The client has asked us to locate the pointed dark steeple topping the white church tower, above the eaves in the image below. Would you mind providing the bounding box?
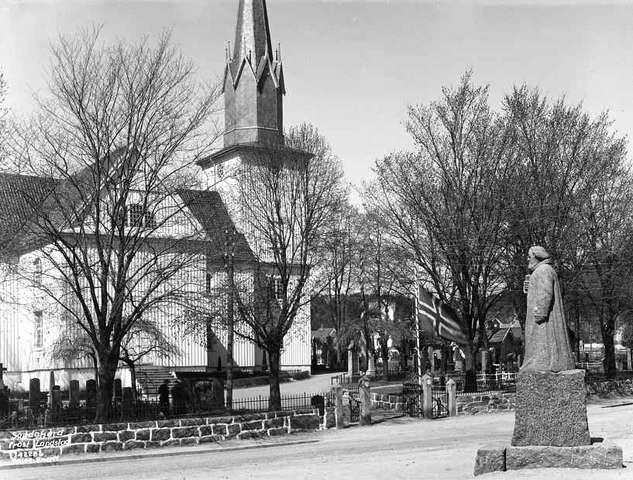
[224,0,285,147]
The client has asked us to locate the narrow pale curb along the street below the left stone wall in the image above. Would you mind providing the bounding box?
[0,439,319,471]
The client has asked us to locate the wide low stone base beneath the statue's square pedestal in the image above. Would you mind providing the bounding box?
[474,439,622,476]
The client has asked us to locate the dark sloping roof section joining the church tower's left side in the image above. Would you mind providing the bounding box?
[178,190,255,262]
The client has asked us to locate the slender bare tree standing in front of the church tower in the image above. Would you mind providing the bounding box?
[232,124,344,409]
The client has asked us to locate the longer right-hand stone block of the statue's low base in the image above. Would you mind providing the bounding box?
[506,440,622,470]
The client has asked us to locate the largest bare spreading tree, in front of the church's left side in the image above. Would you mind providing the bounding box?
[11,31,219,421]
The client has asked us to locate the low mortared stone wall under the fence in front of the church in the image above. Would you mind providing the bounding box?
[0,410,324,462]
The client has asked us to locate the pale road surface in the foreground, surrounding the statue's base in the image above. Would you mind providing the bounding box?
[0,402,633,480]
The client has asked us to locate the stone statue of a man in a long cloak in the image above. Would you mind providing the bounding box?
[521,246,575,372]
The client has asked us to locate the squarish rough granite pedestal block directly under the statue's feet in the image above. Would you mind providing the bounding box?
[512,370,591,447]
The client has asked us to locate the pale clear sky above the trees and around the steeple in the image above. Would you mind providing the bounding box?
[0,0,633,191]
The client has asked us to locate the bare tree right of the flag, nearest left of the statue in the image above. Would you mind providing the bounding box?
[370,74,514,389]
